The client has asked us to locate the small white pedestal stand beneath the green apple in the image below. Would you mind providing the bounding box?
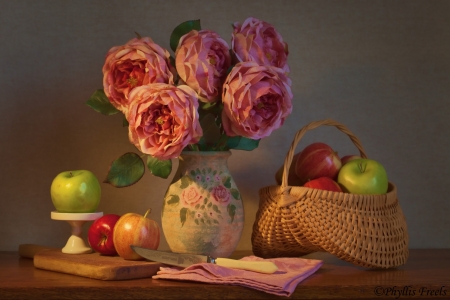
[51,211,103,254]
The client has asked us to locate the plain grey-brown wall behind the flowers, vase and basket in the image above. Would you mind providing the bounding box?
[0,0,450,251]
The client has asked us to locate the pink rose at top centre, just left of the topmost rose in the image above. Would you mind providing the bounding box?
[175,30,231,102]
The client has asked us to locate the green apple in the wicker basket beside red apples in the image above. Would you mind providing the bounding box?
[337,158,388,194]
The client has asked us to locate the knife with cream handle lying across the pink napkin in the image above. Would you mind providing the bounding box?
[130,245,278,274]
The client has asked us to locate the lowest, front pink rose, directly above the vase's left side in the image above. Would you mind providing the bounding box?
[126,83,203,160]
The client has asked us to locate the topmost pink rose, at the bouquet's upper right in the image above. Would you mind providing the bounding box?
[231,18,289,73]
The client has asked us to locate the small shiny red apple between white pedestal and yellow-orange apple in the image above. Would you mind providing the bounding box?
[88,214,120,255]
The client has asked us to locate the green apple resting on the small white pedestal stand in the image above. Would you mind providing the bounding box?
[50,170,101,213]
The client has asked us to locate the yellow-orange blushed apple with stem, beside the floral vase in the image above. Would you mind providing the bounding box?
[113,209,160,260]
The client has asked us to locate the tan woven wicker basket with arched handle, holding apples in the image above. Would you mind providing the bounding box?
[252,120,409,268]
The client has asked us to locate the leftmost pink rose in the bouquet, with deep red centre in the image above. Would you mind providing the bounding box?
[103,37,174,112]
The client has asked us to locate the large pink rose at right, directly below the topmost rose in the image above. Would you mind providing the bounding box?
[222,62,293,139]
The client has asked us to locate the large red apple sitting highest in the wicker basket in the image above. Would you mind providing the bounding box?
[295,143,342,184]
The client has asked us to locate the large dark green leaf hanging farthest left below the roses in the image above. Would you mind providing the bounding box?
[104,152,145,187]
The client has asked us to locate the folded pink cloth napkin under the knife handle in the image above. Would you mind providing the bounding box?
[152,256,323,297]
